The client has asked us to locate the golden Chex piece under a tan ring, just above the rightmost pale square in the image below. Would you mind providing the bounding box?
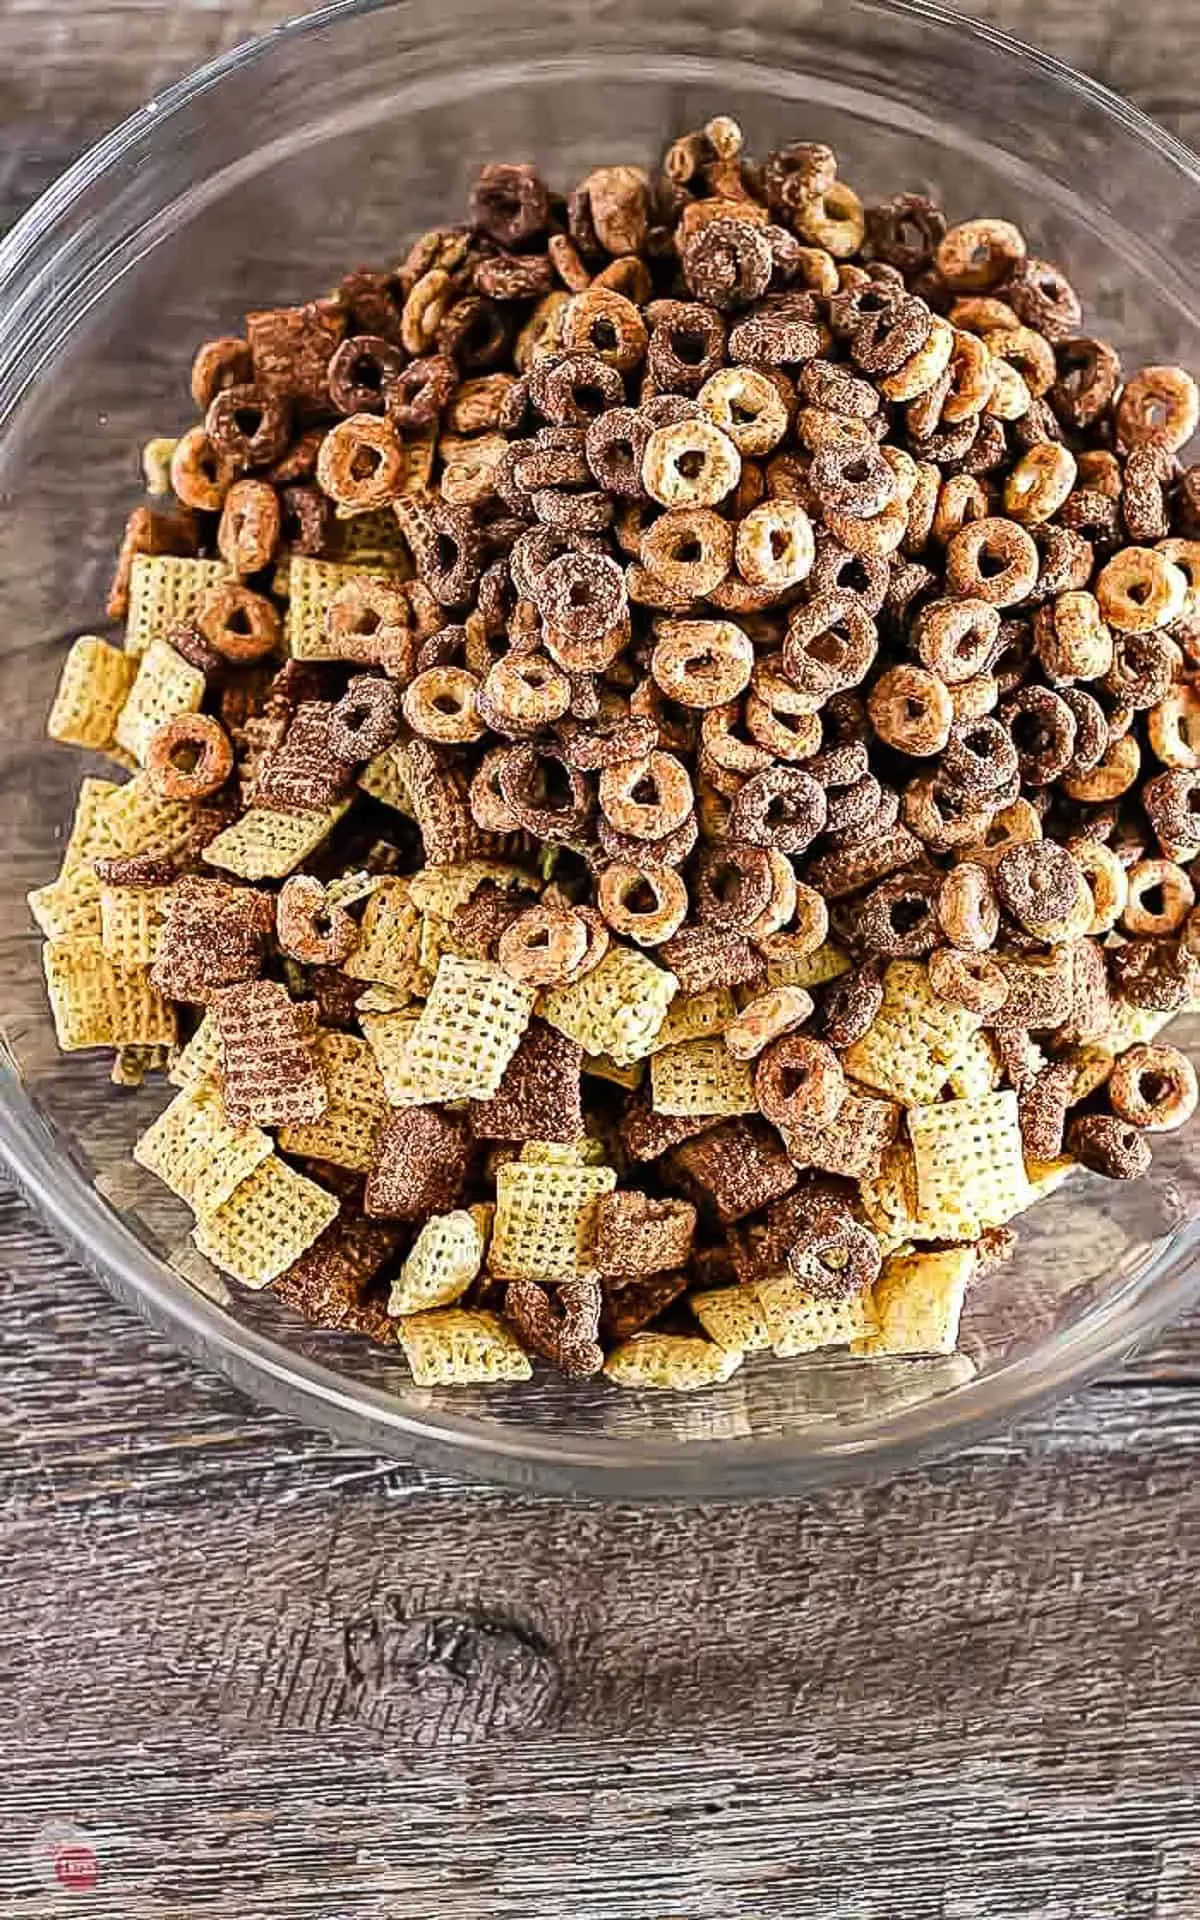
[843,960,979,1106]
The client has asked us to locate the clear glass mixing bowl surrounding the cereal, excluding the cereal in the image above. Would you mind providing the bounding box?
[0,0,1200,1498]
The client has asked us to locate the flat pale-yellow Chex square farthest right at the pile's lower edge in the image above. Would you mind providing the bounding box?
[908,1089,1031,1227]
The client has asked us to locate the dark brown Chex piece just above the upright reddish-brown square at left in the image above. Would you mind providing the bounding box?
[152,874,273,1006]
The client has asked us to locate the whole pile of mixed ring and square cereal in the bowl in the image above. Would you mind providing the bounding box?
[31,119,1200,1388]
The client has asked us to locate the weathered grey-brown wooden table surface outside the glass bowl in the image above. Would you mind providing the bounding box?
[0,0,1200,1920]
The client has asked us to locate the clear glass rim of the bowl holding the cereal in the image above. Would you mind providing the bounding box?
[0,0,1200,1500]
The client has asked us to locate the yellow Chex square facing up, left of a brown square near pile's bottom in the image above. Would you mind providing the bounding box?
[488,1160,616,1281]
